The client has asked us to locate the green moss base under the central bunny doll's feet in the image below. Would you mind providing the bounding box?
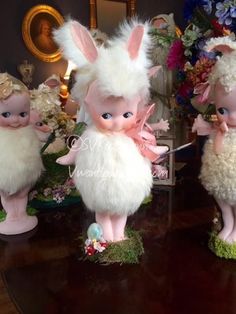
[86,229,144,265]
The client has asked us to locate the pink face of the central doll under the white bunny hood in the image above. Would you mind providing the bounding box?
[85,84,140,132]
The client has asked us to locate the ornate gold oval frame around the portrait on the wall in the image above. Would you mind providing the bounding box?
[22,5,64,62]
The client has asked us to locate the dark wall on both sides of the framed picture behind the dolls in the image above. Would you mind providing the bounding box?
[0,0,184,87]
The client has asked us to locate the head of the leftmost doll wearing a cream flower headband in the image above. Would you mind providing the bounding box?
[0,73,30,129]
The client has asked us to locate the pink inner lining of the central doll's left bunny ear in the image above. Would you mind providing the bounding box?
[71,21,98,63]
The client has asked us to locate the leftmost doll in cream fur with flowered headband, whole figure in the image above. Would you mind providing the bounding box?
[0,73,43,235]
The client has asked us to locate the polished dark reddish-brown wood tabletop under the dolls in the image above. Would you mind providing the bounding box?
[0,164,236,314]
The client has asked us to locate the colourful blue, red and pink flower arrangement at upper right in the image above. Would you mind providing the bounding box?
[166,0,236,116]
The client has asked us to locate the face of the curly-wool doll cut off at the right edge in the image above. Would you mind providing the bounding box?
[214,83,236,127]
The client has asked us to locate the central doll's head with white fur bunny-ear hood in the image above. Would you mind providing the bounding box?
[54,20,151,115]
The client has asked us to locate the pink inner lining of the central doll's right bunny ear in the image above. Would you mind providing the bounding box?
[127,25,144,60]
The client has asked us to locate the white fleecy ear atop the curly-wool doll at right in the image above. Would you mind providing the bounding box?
[205,37,236,54]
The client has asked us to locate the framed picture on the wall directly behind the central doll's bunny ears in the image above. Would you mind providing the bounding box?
[90,0,136,34]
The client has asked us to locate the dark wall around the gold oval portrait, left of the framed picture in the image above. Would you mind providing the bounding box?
[0,0,89,87]
